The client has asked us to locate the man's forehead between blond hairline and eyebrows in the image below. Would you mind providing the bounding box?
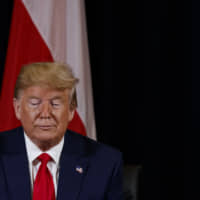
[20,86,70,99]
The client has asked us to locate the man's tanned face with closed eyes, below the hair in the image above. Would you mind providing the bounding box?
[14,86,74,150]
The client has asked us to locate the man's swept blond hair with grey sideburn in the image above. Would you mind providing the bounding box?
[14,62,78,108]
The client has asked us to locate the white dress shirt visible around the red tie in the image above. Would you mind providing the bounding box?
[24,133,64,195]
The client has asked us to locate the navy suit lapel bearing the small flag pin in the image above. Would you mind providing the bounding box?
[57,133,88,200]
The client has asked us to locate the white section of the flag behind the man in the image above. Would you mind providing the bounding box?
[22,0,96,139]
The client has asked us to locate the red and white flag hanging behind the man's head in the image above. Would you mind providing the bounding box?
[0,0,96,139]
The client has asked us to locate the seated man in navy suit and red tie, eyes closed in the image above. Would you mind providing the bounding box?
[0,63,122,200]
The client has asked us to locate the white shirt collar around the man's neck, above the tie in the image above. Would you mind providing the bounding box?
[24,132,64,166]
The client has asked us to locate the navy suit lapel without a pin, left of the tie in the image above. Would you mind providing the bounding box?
[1,127,31,200]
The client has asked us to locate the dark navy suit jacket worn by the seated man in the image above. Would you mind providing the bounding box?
[0,127,122,200]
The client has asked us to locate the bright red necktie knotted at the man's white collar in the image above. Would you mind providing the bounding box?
[33,153,56,200]
